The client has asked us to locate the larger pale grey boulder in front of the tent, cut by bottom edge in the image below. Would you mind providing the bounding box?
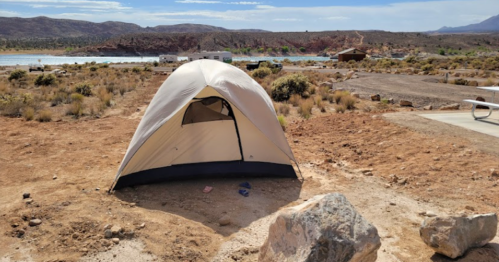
[259,193,381,262]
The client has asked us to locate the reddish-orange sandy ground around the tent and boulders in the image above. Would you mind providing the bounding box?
[0,70,499,262]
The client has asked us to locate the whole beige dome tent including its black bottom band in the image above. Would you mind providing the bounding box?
[111,60,296,190]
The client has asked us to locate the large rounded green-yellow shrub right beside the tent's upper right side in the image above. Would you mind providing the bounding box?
[271,74,310,101]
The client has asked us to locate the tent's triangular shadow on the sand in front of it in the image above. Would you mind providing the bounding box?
[115,178,302,236]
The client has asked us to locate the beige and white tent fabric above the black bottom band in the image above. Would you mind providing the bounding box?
[115,60,296,189]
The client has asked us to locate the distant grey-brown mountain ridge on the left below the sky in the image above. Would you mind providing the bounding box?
[0,16,266,39]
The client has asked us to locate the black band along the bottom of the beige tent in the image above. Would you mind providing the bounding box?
[114,161,297,189]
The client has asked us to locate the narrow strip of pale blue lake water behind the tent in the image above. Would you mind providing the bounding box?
[0,55,329,66]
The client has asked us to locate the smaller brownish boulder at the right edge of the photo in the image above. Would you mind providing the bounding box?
[419,213,497,258]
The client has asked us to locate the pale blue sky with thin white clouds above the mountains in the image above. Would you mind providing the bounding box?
[0,0,499,32]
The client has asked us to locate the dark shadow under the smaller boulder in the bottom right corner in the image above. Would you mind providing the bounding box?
[431,243,499,262]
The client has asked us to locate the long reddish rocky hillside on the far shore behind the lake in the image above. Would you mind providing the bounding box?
[72,31,499,56]
